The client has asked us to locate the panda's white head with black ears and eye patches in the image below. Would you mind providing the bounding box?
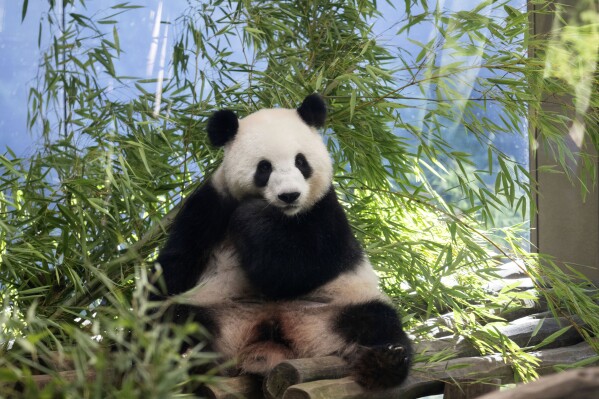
[207,94,333,216]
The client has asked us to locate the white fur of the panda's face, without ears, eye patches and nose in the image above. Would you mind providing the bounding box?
[217,109,333,215]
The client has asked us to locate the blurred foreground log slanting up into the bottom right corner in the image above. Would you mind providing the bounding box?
[479,367,599,399]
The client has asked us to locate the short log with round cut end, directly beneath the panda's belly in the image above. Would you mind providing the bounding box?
[263,356,349,399]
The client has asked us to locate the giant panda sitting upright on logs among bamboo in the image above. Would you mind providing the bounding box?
[157,94,412,389]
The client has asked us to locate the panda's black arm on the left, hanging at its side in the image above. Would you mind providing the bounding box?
[157,181,236,295]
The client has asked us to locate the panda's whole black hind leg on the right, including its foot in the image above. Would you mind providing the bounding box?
[334,300,412,390]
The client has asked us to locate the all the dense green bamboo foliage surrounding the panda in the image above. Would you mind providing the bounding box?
[0,0,599,397]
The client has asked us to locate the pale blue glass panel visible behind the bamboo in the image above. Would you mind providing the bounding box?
[0,0,528,239]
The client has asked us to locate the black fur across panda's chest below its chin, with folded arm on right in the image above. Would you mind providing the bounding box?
[230,187,363,299]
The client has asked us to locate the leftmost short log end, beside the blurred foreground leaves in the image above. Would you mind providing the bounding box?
[200,375,263,399]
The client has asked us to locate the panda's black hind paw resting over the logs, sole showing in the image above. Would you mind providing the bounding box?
[351,345,410,390]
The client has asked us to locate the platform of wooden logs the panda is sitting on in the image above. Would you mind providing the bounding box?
[206,343,599,399]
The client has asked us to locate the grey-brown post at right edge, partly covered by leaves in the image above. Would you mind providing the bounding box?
[528,0,599,283]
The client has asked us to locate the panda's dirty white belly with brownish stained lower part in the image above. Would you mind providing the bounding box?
[190,256,383,374]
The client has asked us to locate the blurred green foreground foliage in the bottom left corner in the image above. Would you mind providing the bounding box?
[0,269,217,398]
